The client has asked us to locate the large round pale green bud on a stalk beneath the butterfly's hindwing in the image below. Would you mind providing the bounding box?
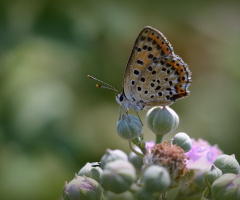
[146,106,179,136]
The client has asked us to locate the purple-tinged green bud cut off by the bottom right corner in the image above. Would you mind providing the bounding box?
[211,174,240,200]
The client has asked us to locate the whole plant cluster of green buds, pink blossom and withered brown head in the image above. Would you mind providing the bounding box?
[63,106,240,200]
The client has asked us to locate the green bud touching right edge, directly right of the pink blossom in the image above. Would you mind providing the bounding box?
[213,154,239,174]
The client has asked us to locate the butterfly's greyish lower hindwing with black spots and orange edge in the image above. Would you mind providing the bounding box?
[132,55,191,106]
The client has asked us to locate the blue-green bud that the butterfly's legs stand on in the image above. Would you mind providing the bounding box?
[117,115,143,140]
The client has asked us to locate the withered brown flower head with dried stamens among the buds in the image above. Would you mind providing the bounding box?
[144,142,189,185]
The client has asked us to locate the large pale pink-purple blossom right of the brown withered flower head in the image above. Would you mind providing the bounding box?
[186,138,223,170]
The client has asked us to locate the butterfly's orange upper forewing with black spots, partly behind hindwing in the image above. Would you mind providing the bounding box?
[123,26,174,99]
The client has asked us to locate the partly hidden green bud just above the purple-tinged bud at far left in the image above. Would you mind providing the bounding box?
[78,163,103,183]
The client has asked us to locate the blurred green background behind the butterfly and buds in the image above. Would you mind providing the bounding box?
[0,0,240,200]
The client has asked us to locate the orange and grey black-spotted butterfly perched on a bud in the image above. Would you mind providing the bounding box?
[88,26,191,119]
